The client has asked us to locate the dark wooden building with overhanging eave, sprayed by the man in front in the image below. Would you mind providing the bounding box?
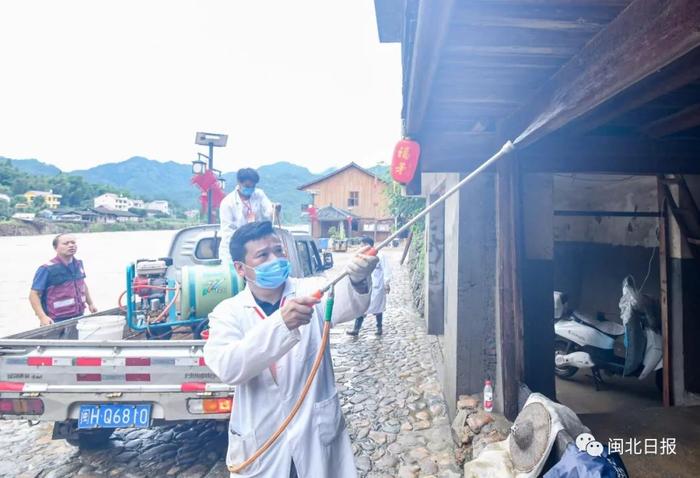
[375,0,700,476]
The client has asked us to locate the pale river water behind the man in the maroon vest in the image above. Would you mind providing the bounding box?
[0,231,176,337]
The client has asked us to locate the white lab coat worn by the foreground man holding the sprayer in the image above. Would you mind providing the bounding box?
[204,278,370,478]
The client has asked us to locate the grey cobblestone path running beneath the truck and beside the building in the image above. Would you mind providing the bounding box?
[0,254,461,478]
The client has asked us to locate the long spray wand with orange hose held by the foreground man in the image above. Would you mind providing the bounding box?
[228,141,515,473]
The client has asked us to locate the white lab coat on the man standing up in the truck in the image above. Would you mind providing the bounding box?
[219,188,273,264]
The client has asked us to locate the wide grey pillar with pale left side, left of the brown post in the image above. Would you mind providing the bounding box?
[443,173,499,416]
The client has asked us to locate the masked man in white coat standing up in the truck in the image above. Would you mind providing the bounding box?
[219,168,275,264]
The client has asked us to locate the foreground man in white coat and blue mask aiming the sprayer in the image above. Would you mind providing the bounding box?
[204,221,377,478]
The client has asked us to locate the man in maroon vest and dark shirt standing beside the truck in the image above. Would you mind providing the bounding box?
[29,234,97,326]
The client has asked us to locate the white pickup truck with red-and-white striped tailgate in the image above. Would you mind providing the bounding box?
[0,225,333,447]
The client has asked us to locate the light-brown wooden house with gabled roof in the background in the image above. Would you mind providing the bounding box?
[298,163,394,241]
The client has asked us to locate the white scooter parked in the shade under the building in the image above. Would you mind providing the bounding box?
[554,276,663,390]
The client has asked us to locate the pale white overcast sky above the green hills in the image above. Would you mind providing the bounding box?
[0,0,401,172]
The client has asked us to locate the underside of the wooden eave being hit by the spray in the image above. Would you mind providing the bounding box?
[403,0,700,175]
